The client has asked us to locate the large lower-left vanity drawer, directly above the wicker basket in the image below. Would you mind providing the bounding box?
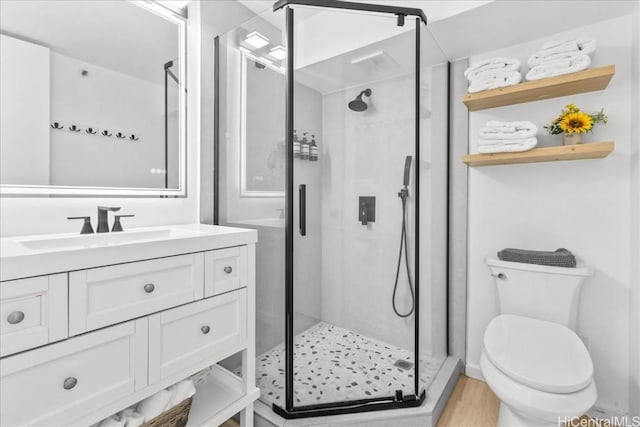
[0,319,148,427]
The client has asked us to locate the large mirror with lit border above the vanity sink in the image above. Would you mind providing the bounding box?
[0,0,186,196]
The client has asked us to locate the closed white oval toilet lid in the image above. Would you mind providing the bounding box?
[484,314,593,393]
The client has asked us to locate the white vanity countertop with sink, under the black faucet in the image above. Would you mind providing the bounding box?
[0,224,258,281]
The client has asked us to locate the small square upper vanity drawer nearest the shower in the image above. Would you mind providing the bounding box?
[204,246,247,297]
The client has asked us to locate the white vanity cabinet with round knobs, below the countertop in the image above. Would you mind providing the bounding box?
[0,226,259,427]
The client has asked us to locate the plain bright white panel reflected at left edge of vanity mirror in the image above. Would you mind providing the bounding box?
[0,34,50,185]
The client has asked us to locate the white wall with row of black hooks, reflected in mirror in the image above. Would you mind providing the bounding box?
[51,52,170,188]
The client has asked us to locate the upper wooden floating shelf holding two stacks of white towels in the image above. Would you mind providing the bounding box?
[462,65,616,111]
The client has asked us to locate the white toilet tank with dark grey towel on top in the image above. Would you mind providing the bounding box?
[485,258,593,330]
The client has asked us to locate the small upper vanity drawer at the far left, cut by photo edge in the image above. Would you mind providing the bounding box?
[0,273,68,357]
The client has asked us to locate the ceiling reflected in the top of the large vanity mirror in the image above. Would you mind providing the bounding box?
[0,0,179,83]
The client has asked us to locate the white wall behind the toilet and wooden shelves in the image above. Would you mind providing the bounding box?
[464,16,637,411]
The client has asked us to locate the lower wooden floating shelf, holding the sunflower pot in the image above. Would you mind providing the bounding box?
[462,141,614,166]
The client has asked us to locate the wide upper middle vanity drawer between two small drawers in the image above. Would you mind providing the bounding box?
[69,253,204,335]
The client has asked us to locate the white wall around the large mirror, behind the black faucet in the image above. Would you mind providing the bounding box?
[0,2,200,236]
